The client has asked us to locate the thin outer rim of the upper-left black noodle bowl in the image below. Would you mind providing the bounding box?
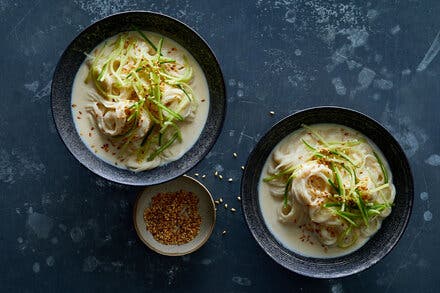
[49,10,227,186]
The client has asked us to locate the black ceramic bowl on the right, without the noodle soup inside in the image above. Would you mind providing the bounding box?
[241,107,414,278]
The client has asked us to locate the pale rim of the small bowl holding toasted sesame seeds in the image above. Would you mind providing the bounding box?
[133,175,217,256]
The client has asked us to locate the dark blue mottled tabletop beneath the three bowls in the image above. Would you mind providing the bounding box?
[0,0,440,292]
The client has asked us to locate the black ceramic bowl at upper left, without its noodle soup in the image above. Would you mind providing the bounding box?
[51,11,226,185]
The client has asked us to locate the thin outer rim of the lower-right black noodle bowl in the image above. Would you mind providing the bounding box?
[240,105,414,279]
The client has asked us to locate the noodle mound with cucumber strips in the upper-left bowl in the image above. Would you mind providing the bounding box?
[85,31,198,162]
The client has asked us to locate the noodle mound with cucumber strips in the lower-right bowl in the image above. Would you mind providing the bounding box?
[262,124,395,254]
